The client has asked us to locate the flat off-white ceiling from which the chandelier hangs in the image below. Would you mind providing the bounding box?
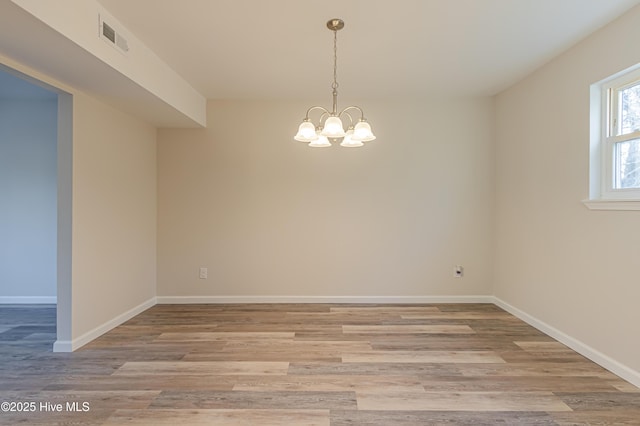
[99,0,640,99]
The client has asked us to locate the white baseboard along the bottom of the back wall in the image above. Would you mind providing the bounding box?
[157,296,493,305]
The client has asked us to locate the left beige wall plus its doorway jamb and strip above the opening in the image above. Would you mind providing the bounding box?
[0,54,157,350]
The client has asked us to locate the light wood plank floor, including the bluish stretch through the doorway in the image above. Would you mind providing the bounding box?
[0,304,640,426]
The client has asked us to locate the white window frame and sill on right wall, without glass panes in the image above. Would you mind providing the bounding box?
[583,64,640,210]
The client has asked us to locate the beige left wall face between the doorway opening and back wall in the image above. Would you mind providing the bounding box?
[72,93,156,339]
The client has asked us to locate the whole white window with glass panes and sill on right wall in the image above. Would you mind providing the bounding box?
[585,67,640,210]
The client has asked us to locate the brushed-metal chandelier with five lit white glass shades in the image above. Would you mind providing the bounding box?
[294,18,376,148]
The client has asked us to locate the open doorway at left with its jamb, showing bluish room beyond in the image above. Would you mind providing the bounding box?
[0,64,72,351]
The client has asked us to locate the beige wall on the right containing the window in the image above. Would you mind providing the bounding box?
[494,8,640,372]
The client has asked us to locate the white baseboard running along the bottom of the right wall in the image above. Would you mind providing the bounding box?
[493,297,640,388]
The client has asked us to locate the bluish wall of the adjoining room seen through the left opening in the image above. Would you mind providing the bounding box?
[0,98,57,303]
